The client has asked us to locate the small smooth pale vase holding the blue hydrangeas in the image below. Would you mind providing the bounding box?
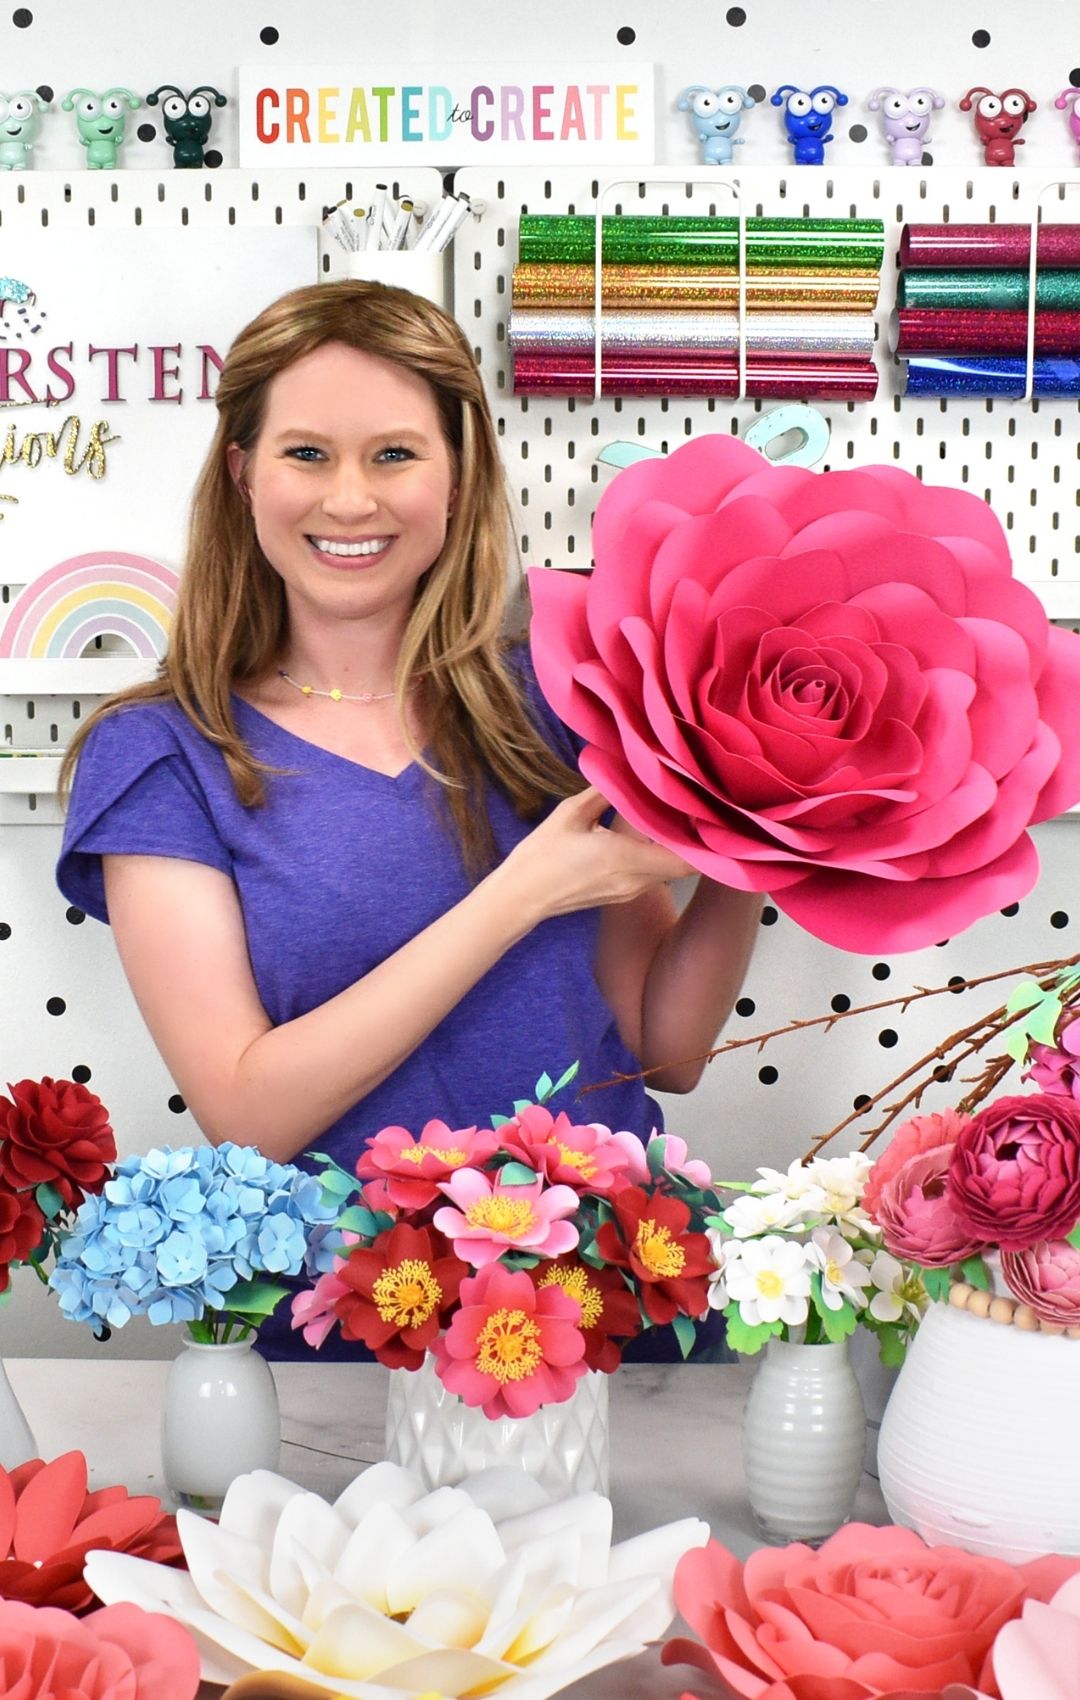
[162,1340,281,1515]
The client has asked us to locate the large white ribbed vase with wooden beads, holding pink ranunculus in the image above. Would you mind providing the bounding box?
[878,1304,1080,1561]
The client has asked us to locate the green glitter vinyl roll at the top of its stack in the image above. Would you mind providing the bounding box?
[517,213,884,270]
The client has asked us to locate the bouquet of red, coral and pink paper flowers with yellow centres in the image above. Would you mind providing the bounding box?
[293,1066,719,1418]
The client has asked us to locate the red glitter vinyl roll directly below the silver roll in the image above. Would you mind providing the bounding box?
[514,352,878,401]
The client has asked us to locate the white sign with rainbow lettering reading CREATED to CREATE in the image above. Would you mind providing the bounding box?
[240,61,657,168]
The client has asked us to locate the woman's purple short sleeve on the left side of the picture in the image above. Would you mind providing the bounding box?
[56,706,231,921]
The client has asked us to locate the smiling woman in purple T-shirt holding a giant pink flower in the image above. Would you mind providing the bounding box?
[58,282,759,1350]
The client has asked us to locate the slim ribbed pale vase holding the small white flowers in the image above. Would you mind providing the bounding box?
[743,1340,866,1544]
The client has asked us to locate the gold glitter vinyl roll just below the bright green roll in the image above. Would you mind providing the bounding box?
[510,265,879,313]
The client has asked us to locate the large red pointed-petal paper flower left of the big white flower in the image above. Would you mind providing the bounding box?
[0,1452,184,1611]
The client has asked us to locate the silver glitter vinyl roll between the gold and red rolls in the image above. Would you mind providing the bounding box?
[507,308,874,360]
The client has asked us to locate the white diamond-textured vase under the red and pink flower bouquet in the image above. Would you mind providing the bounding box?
[386,1357,609,1499]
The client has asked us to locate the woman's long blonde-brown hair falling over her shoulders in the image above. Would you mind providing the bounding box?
[60,282,583,876]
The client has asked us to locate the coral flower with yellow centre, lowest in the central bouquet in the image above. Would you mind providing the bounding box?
[432,1263,585,1418]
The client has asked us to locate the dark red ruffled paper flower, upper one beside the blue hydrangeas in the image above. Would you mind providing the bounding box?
[0,1074,116,1210]
